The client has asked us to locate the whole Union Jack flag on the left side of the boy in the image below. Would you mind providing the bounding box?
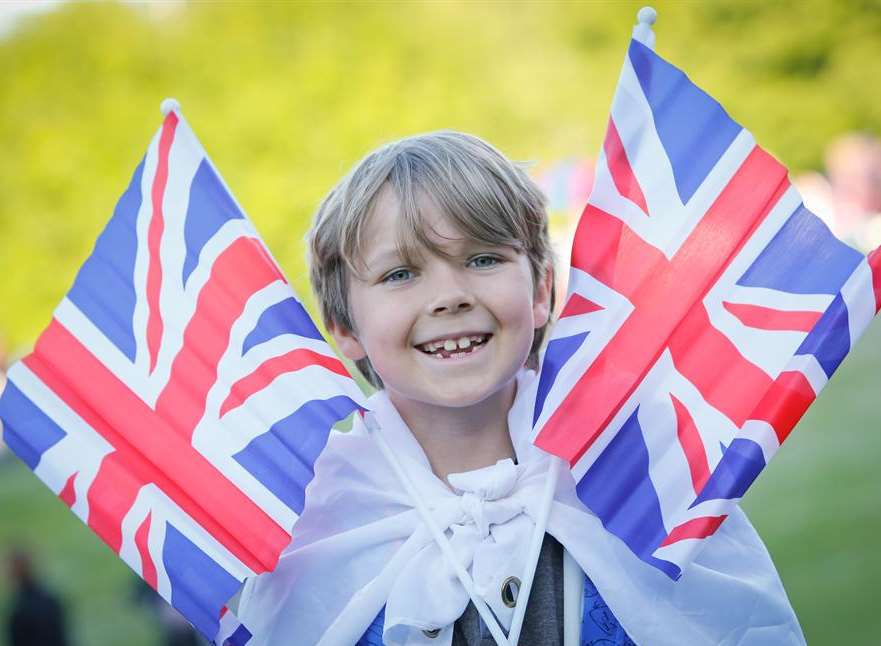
[0,107,363,644]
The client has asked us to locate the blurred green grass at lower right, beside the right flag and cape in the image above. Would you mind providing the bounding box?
[743,320,881,644]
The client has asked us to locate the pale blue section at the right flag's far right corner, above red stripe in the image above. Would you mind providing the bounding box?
[737,204,863,295]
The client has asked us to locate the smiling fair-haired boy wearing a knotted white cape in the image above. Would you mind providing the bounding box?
[239,132,804,646]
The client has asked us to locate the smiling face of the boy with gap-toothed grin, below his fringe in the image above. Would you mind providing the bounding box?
[331,188,550,408]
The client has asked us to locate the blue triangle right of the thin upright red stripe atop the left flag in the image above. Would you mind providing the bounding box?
[181,159,245,285]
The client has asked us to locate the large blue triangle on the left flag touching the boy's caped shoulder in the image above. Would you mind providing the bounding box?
[234,395,359,514]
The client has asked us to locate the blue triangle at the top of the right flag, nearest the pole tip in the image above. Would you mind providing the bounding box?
[629,40,743,204]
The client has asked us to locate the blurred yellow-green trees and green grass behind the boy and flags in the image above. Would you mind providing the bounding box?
[0,0,881,646]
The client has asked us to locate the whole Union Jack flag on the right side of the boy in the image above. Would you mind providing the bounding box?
[533,39,881,579]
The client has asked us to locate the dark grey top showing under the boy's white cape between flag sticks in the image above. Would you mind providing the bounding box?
[453,534,563,646]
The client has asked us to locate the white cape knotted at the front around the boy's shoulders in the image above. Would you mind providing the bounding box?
[239,372,804,646]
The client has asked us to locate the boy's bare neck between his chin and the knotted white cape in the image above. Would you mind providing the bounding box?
[388,381,517,484]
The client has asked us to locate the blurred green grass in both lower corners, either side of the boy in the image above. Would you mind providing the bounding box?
[0,321,881,646]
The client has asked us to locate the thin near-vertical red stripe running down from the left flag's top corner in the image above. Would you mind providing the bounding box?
[147,112,178,373]
